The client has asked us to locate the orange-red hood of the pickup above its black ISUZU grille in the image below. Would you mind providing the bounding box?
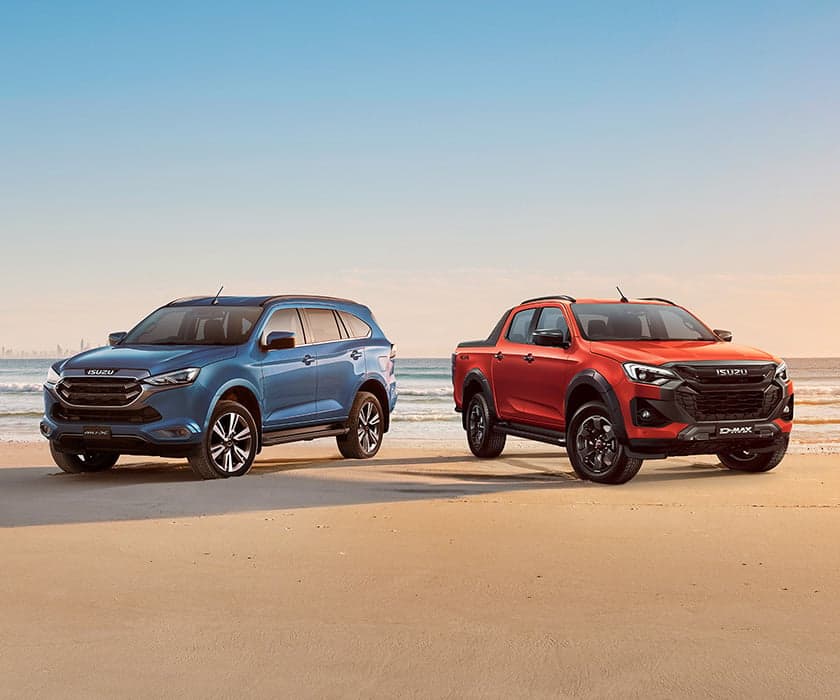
[590,340,781,365]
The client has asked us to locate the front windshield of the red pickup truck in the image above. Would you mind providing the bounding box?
[572,303,717,341]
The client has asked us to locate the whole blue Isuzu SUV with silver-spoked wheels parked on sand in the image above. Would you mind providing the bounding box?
[41,296,397,479]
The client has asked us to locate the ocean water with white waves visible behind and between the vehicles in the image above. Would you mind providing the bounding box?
[0,358,840,453]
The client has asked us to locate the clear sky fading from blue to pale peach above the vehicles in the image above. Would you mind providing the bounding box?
[0,0,840,357]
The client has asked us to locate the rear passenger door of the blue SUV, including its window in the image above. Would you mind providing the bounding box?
[303,308,366,421]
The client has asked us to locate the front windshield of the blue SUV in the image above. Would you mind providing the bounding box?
[120,306,262,345]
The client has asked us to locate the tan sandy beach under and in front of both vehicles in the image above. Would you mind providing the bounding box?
[0,443,840,698]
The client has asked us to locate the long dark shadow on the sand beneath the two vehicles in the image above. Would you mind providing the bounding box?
[0,453,732,527]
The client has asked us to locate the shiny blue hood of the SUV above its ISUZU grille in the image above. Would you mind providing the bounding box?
[61,345,236,375]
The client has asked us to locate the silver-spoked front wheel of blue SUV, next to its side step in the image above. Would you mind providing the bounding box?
[188,401,259,479]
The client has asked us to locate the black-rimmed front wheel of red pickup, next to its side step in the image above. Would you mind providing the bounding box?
[566,401,642,484]
